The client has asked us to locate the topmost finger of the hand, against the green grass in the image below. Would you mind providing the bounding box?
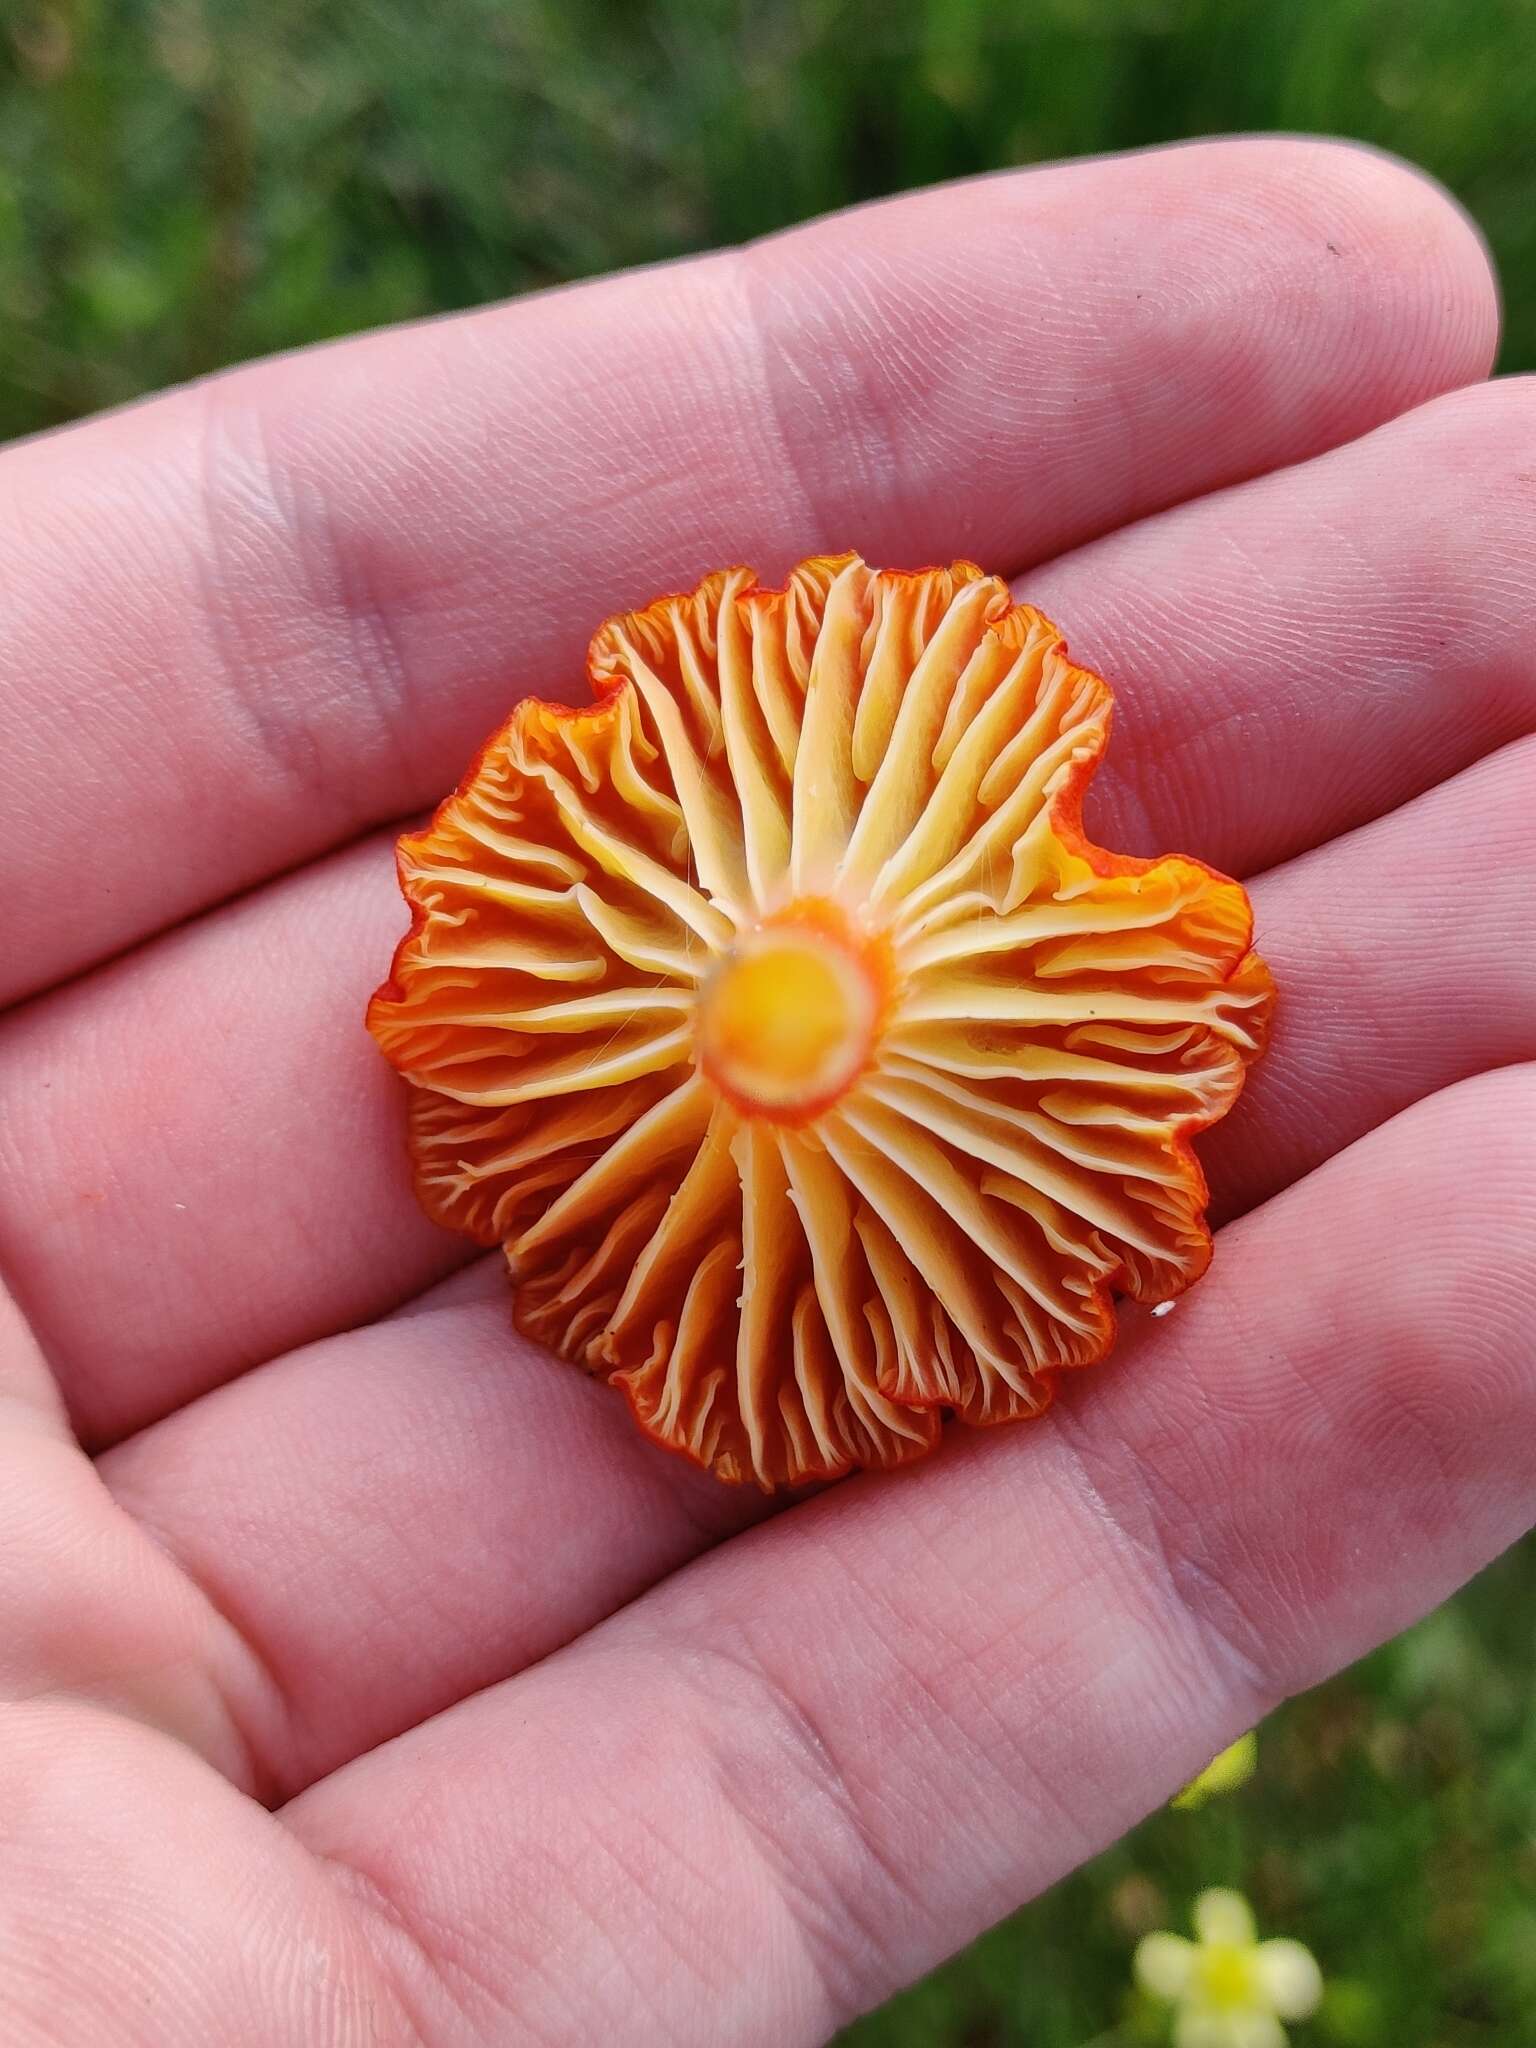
[0,139,1495,995]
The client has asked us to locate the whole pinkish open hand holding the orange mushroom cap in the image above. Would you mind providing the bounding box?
[0,141,1536,2048]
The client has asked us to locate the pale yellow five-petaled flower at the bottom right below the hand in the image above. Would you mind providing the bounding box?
[1135,1890,1323,2048]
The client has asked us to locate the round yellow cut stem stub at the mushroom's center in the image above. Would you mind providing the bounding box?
[698,924,881,1118]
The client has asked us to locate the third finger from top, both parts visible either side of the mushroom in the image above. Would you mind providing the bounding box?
[102,741,1536,1788]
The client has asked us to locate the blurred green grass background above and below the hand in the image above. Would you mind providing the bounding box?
[0,0,1536,2048]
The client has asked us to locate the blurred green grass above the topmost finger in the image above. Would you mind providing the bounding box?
[0,0,1536,434]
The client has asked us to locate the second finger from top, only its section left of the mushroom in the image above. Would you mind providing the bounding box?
[0,838,475,1444]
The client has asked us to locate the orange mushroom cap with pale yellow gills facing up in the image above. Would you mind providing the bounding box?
[369,555,1274,1489]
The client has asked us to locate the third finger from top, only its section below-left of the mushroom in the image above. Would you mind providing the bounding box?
[98,1260,782,1796]
